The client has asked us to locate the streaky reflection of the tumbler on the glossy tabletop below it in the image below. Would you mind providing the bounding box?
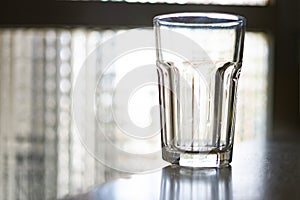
[160,165,232,200]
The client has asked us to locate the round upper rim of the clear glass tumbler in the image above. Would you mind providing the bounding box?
[153,12,246,28]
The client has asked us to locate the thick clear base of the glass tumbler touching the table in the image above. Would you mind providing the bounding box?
[162,147,232,168]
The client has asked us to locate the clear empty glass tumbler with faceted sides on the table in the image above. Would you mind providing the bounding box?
[154,13,245,167]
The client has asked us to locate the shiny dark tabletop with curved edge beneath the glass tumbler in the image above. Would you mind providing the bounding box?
[69,134,300,200]
